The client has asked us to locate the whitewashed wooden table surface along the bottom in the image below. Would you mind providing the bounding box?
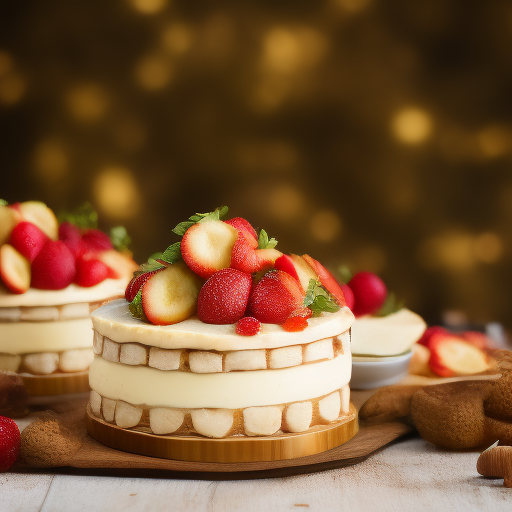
[0,438,512,512]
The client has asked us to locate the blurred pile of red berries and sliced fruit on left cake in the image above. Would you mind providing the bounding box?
[0,201,137,293]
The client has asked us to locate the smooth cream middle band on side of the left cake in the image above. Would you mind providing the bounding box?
[0,318,93,354]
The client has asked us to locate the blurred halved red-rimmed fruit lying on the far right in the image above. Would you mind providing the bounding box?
[429,333,489,377]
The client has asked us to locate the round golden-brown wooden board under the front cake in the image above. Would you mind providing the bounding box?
[85,404,359,463]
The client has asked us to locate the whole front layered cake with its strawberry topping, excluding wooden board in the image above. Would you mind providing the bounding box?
[89,208,355,451]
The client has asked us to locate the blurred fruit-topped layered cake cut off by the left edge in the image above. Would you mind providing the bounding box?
[0,201,137,395]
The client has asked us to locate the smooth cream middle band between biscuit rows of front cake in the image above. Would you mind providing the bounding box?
[89,352,352,409]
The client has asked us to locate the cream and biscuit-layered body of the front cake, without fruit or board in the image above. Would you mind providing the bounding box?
[89,300,353,437]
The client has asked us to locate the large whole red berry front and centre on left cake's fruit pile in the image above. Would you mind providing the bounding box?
[31,240,76,290]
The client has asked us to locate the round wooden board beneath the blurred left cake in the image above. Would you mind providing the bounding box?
[20,370,90,399]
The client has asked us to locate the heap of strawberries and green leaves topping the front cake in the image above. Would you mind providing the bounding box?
[125,207,345,336]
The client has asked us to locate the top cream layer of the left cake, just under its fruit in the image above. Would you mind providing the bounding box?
[0,277,129,308]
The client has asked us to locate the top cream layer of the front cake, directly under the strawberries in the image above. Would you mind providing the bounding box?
[92,299,354,351]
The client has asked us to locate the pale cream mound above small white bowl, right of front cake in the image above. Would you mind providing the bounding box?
[352,308,427,356]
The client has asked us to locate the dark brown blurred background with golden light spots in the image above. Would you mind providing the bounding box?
[0,0,512,328]
